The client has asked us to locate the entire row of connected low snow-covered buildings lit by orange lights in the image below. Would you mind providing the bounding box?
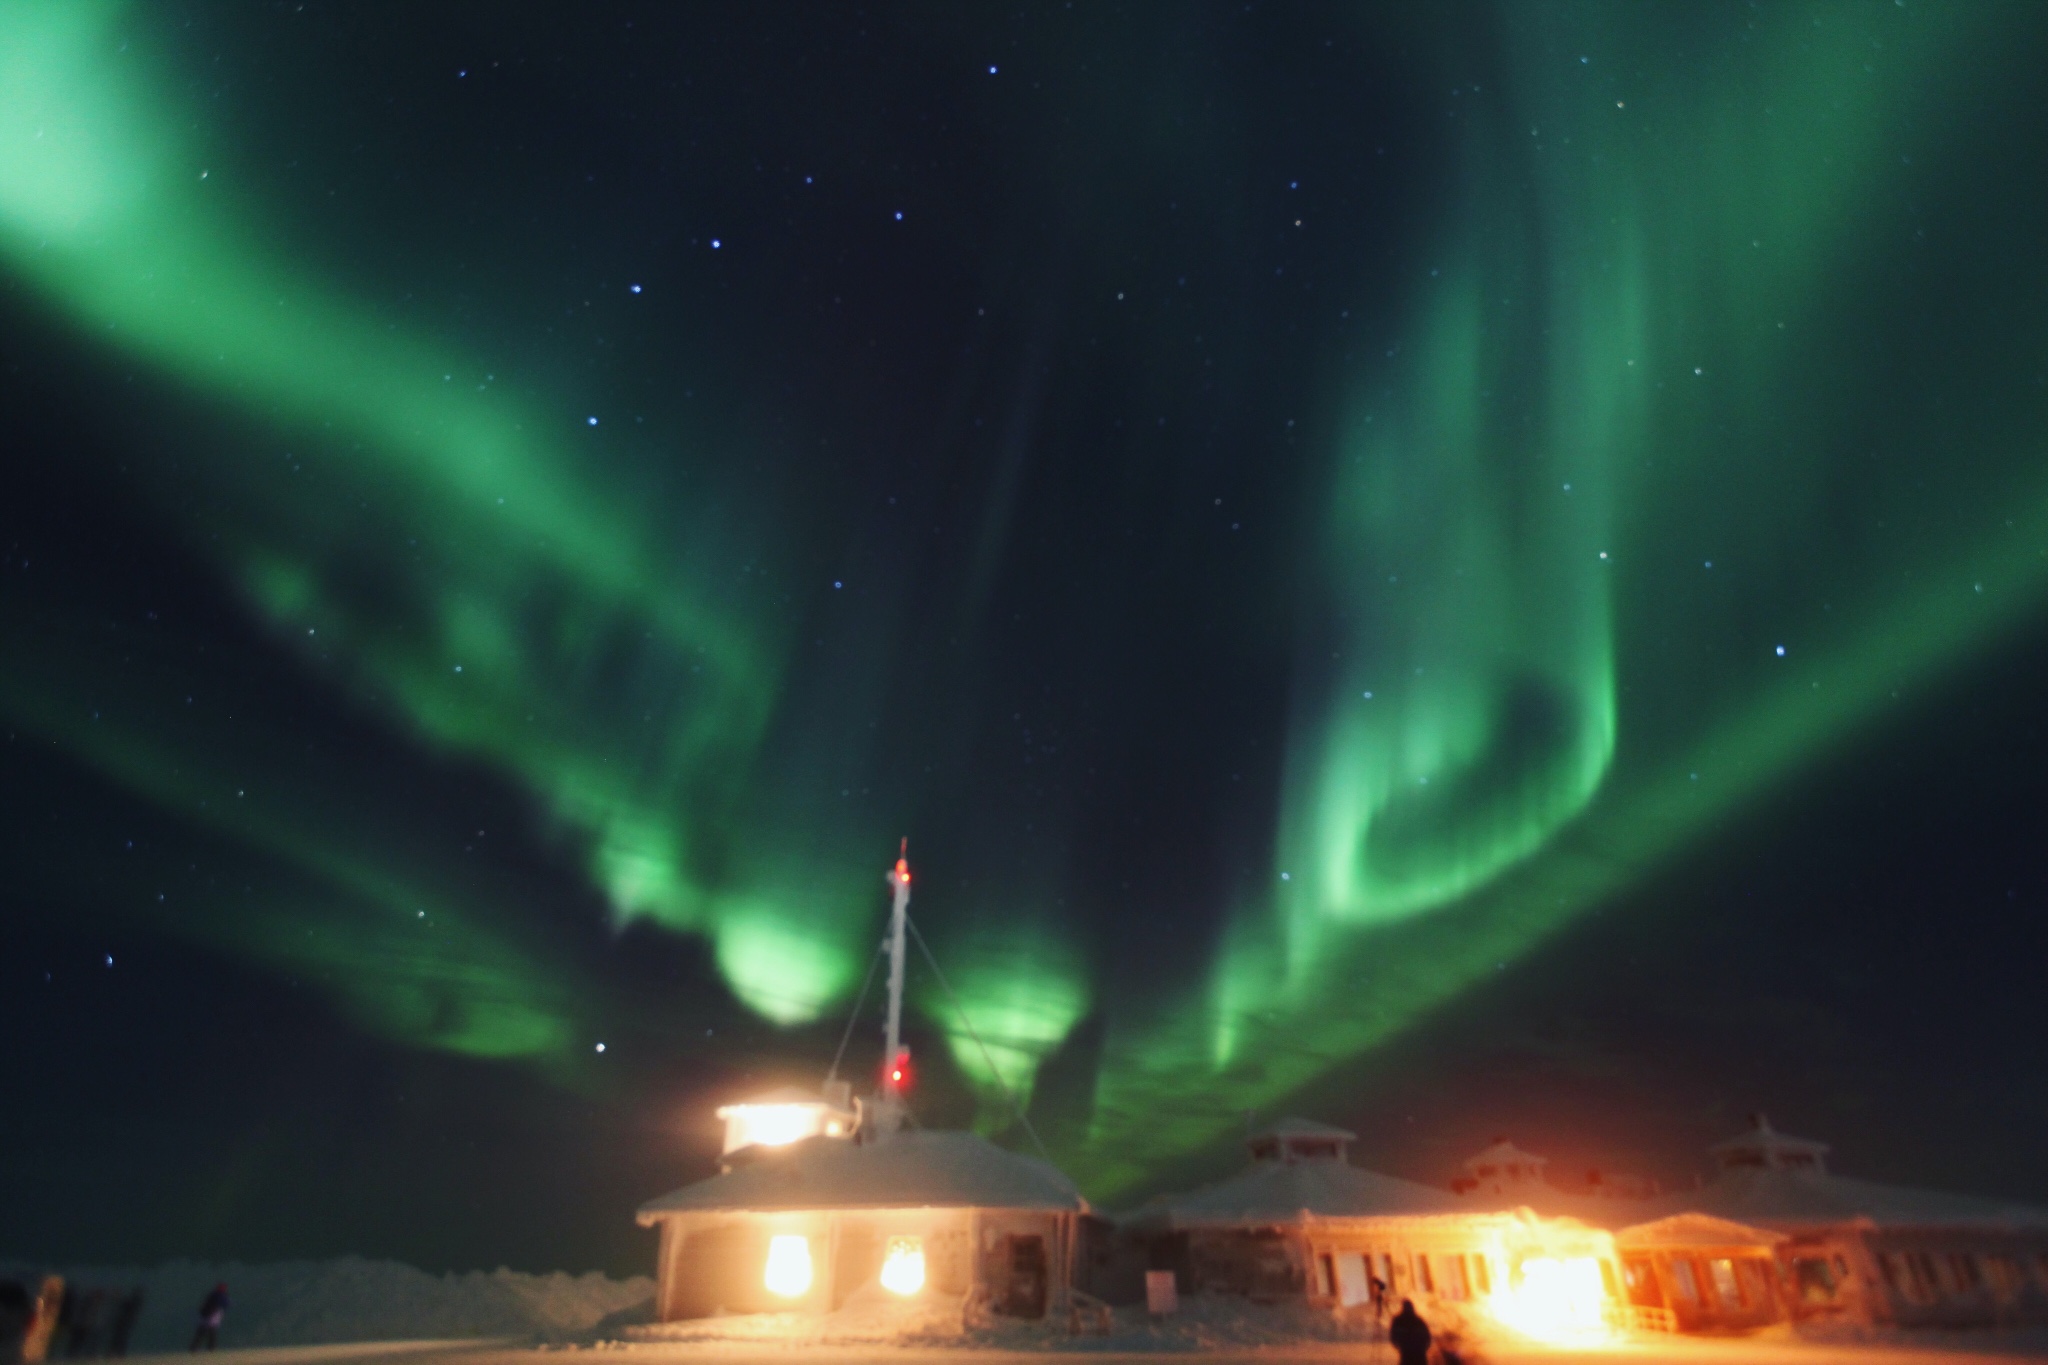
[639,1091,2048,1338]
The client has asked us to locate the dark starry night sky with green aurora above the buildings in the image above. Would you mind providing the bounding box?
[0,0,2048,1271]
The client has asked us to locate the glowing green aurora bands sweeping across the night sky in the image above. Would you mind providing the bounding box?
[0,4,2048,1195]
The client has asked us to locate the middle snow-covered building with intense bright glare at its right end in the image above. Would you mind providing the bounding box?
[1124,1119,1622,1328]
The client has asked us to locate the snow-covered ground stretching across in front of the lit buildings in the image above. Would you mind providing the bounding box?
[19,1257,2048,1365]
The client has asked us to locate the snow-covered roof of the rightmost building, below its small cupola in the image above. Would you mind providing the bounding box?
[1647,1166,2048,1230]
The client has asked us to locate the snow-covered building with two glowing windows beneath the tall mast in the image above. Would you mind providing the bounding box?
[639,1130,1092,1322]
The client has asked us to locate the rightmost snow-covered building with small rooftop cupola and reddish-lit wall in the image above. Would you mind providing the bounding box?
[1624,1115,2048,1326]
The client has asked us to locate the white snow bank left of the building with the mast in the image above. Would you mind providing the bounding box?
[24,1257,653,1355]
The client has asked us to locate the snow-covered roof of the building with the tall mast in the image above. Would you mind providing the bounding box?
[639,1130,1087,1224]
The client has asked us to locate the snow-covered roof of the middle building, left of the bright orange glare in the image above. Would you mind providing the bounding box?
[1128,1160,1470,1232]
